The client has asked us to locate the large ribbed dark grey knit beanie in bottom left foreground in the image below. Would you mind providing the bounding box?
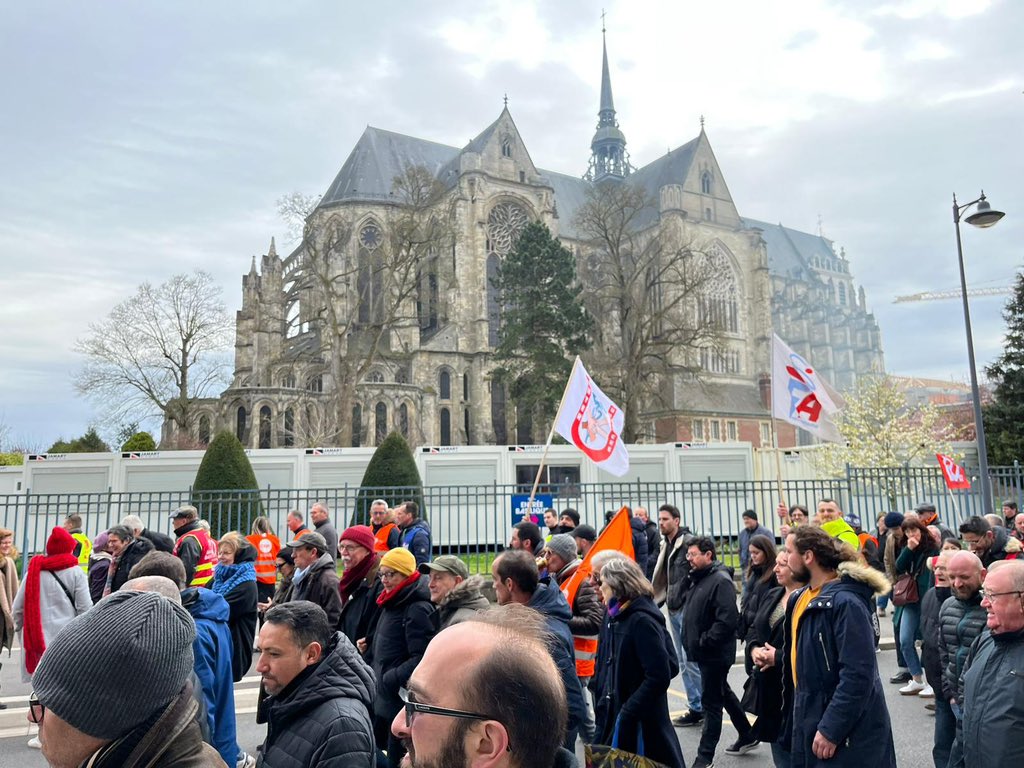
[32,592,196,739]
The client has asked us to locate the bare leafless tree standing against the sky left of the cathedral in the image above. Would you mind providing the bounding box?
[75,271,233,444]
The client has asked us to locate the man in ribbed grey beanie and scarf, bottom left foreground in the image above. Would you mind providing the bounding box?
[29,591,224,768]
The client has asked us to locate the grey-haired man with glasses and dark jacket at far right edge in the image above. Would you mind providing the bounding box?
[949,560,1024,768]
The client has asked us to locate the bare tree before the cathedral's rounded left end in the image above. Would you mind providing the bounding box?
[285,166,455,445]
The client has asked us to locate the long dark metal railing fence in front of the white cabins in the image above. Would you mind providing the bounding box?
[0,464,1024,573]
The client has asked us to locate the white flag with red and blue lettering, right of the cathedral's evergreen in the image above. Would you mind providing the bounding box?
[771,334,846,442]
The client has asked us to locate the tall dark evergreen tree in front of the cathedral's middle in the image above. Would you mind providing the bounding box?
[494,222,594,438]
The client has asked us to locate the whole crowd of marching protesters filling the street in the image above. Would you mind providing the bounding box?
[0,499,1024,768]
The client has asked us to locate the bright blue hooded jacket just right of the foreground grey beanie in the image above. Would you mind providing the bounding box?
[181,587,239,766]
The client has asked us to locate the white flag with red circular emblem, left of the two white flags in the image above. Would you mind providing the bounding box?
[555,357,630,477]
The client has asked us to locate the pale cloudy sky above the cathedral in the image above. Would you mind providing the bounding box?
[0,0,1024,449]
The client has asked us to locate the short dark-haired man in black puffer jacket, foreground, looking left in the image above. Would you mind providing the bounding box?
[256,600,376,768]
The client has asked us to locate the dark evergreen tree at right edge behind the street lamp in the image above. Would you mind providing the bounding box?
[983,272,1024,465]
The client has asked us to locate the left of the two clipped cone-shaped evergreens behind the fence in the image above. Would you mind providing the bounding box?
[191,429,263,539]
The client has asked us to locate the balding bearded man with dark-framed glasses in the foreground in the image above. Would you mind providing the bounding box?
[391,605,577,768]
